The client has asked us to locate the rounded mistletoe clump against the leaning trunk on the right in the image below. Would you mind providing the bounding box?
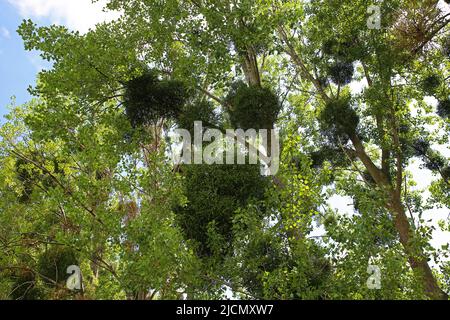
[319,98,359,147]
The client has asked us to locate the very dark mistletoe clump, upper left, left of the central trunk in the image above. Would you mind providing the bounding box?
[124,71,188,127]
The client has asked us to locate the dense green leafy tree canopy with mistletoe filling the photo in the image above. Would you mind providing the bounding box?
[0,0,450,299]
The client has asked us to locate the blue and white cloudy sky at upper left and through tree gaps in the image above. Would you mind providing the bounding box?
[0,0,450,255]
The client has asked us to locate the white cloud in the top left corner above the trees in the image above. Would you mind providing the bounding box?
[8,0,119,33]
